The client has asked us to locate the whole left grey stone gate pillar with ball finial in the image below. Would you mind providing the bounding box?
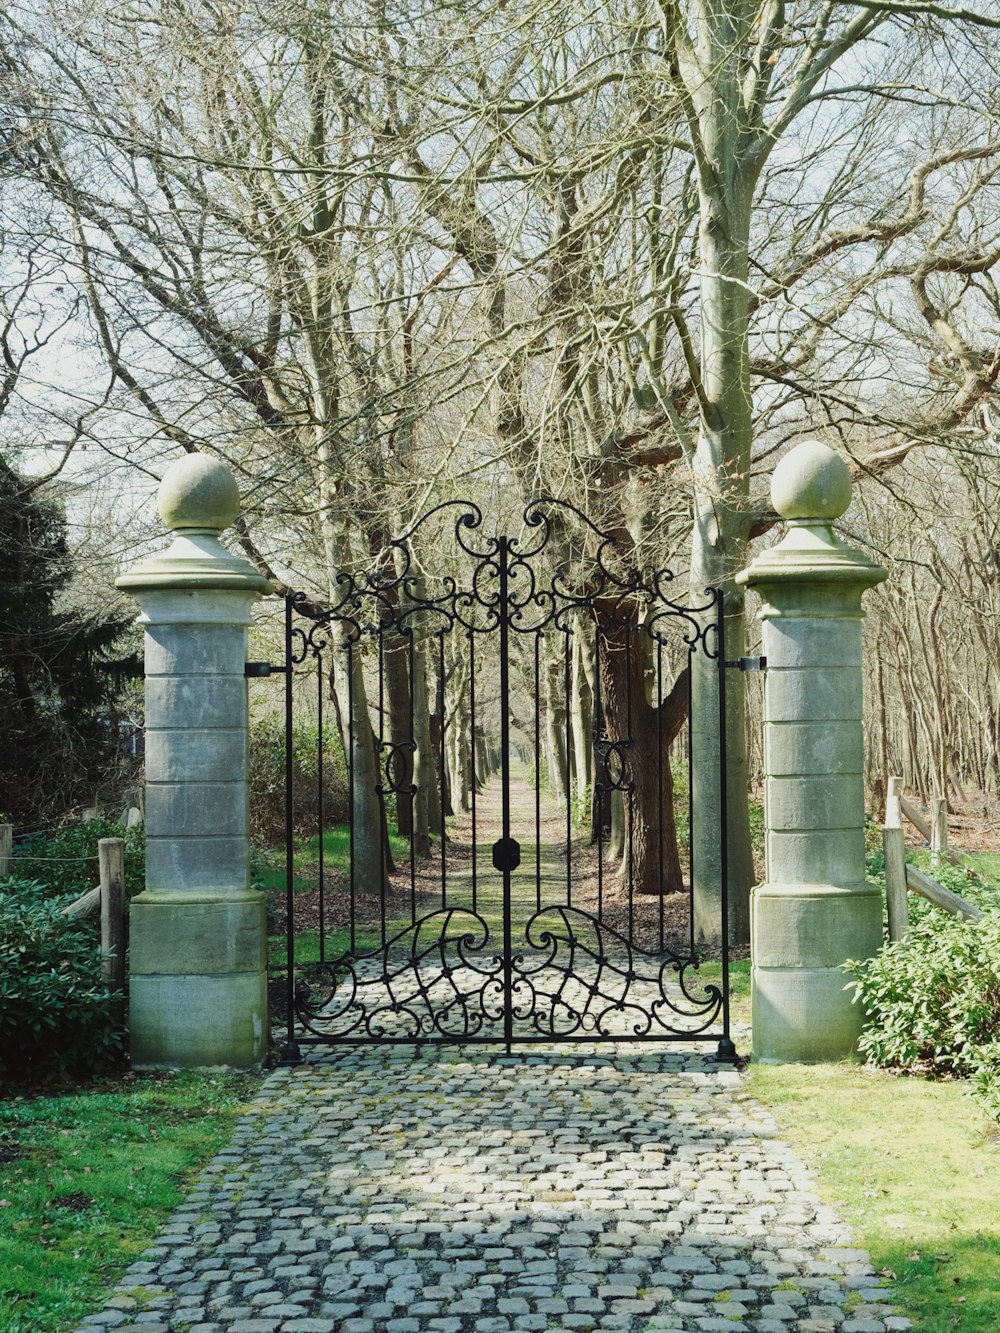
[117,453,271,1069]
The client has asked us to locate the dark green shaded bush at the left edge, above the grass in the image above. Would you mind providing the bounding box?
[0,880,123,1076]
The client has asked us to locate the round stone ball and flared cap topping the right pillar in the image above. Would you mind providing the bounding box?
[736,440,888,599]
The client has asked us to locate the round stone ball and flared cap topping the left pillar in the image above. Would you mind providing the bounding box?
[116,453,275,596]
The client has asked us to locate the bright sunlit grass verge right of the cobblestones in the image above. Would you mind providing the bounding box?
[747,1064,1000,1333]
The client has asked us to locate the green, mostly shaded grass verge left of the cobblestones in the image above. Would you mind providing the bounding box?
[0,1073,259,1333]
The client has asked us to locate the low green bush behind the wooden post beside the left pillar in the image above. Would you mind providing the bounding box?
[12,820,145,898]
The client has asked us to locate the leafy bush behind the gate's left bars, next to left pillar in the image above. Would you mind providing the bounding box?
[249,717,348,846]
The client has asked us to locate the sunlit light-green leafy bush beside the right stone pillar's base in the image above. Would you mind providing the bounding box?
[847,911,1000,1117]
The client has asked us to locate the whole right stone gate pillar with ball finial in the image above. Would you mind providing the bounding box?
[736,441,885,1062]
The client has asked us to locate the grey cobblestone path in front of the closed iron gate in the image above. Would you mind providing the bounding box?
[79,1046,909,1333]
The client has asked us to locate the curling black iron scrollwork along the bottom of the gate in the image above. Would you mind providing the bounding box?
[296,904,723,1044]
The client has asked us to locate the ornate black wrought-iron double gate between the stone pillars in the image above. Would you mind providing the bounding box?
[274,501,733,1058]
